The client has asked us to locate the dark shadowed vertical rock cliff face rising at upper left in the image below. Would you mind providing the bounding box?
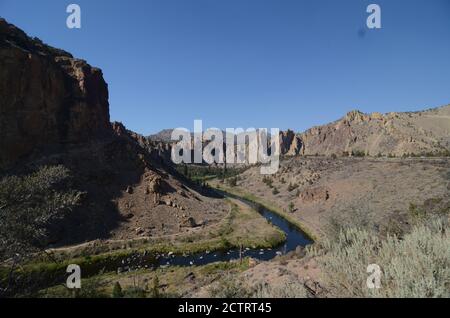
[0,19,110,167]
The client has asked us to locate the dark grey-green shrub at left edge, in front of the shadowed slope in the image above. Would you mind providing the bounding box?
[0,166,81,259]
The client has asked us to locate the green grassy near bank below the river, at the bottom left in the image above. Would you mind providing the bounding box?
[36,258,253,298]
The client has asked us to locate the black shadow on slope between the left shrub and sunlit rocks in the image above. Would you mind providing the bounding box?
[35,137,155,247]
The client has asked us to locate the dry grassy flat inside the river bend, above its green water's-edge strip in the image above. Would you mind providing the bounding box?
[43,198,286,259]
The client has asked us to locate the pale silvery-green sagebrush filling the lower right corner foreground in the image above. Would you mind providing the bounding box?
[310,220,450,298]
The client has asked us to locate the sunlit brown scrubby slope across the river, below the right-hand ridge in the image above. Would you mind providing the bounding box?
[214,157,450,237]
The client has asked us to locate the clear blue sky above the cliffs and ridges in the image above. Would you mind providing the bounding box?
[0,0,450,134]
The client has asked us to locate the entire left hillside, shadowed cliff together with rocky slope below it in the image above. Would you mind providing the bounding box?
[0,19,228,244]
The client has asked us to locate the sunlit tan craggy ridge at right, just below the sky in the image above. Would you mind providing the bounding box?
[148,105,450,156]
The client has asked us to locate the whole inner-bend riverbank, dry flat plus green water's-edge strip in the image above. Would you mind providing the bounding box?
[0,199,286,296]
